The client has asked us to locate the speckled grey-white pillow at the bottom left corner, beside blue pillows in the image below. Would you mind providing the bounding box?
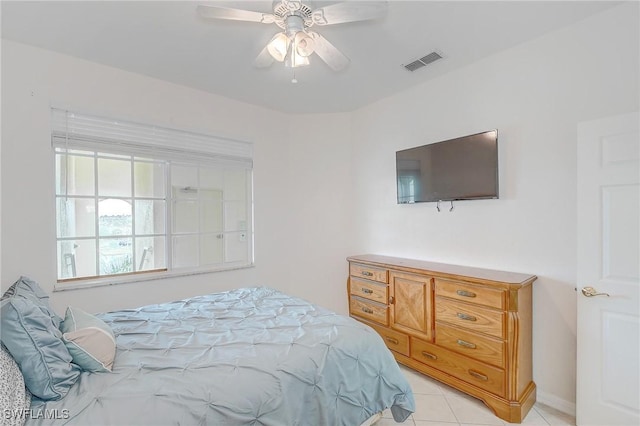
[0,345,31,426]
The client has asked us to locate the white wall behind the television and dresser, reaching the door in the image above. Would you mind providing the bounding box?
[352,2,639,411]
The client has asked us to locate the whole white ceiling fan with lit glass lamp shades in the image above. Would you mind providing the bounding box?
[198,0,387,73]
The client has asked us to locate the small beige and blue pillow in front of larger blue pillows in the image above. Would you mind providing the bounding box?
[60,306,116,372]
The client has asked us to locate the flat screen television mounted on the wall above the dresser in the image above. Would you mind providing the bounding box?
[396,130,498,204]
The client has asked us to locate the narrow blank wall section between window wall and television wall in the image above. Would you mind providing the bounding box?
[289,114,355,313]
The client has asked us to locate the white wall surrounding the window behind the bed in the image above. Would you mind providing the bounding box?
[1,40,291,315]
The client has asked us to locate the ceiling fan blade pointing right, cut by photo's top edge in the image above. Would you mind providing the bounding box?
[311,1,388,25]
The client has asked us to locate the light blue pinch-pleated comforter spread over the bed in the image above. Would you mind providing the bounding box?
[26,287,414,426]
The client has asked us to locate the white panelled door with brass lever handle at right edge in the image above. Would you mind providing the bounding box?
[576,113,640,426]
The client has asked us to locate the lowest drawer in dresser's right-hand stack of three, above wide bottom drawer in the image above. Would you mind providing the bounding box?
[436,323,506,368]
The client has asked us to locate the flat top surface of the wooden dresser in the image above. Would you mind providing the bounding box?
[347,254,536,285]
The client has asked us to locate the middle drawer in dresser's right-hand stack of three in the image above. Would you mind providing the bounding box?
[435,297,505,338]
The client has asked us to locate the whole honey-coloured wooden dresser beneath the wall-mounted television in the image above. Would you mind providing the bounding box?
[347,255,536,423]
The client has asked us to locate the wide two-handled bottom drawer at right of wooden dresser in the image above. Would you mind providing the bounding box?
[411,337,506,397]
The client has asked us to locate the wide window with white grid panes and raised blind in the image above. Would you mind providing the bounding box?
[52,109,253,283]
